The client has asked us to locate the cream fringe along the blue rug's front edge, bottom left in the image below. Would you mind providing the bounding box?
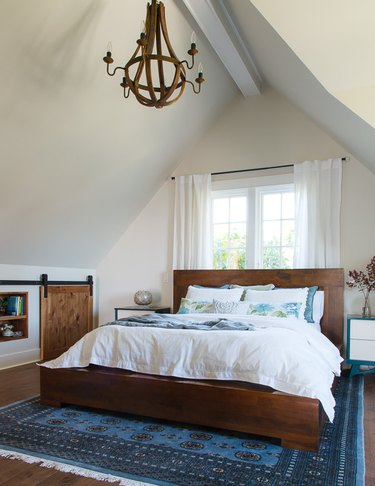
[0,449,152,486]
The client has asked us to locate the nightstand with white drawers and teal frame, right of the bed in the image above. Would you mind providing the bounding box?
[346,316,375,376]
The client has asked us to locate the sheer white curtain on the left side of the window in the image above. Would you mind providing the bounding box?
[173,174,212,270]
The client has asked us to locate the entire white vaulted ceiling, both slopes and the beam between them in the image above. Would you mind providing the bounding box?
[0,0,375,268]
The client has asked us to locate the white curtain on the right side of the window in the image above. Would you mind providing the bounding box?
[294,159,342,268]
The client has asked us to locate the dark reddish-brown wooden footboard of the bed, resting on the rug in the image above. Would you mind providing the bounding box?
[40,366,325,451]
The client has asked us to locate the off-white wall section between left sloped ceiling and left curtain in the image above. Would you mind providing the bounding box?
[97,180,173,322]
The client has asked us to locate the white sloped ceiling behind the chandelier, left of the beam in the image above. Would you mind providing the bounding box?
[0,0,238,267]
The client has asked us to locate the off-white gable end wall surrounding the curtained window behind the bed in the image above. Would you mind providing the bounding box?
[97,90,375,321]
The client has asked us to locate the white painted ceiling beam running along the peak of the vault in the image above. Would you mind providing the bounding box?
[182,0,262,96]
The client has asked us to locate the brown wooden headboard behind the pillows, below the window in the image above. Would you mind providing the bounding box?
[173,268,344,346]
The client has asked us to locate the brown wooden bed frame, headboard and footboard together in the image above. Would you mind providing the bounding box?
[40,269,344,451]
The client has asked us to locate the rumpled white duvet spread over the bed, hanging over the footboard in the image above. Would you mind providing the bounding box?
[42,314,342,421]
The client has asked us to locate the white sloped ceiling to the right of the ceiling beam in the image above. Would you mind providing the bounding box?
[188,0,375,172]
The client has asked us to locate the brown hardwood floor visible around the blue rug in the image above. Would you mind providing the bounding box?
[0,364,375,486]
